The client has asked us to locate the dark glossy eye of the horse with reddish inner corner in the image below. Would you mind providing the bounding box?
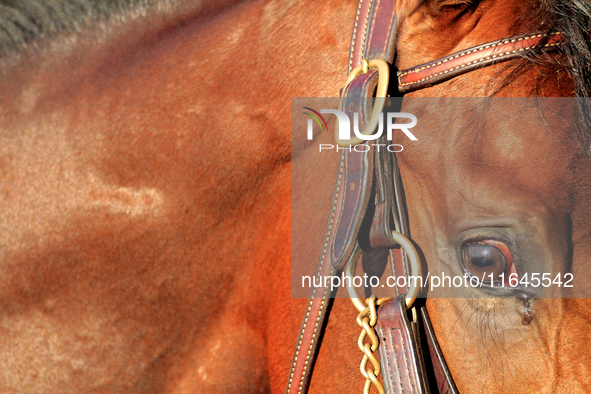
[462,240,513,285]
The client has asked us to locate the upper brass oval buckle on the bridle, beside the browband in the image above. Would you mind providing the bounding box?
[335,59,390,147]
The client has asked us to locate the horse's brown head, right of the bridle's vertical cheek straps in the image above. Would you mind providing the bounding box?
[384,0,591,392]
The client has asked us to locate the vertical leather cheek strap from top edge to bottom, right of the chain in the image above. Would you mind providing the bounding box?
[343,0,428,393]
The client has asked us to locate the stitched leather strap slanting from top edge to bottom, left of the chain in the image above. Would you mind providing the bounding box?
[286,0,396,393]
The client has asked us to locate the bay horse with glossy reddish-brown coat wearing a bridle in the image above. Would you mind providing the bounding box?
[0,0,591,393]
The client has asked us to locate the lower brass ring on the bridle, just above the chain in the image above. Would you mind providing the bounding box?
[345,231,423,312]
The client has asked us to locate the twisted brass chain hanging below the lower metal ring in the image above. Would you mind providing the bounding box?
[357,296,389,394]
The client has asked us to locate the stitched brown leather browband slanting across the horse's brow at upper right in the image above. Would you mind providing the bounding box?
[398,32,565,93]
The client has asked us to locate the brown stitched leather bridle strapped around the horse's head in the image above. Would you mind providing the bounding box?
[286,0,565,393]
